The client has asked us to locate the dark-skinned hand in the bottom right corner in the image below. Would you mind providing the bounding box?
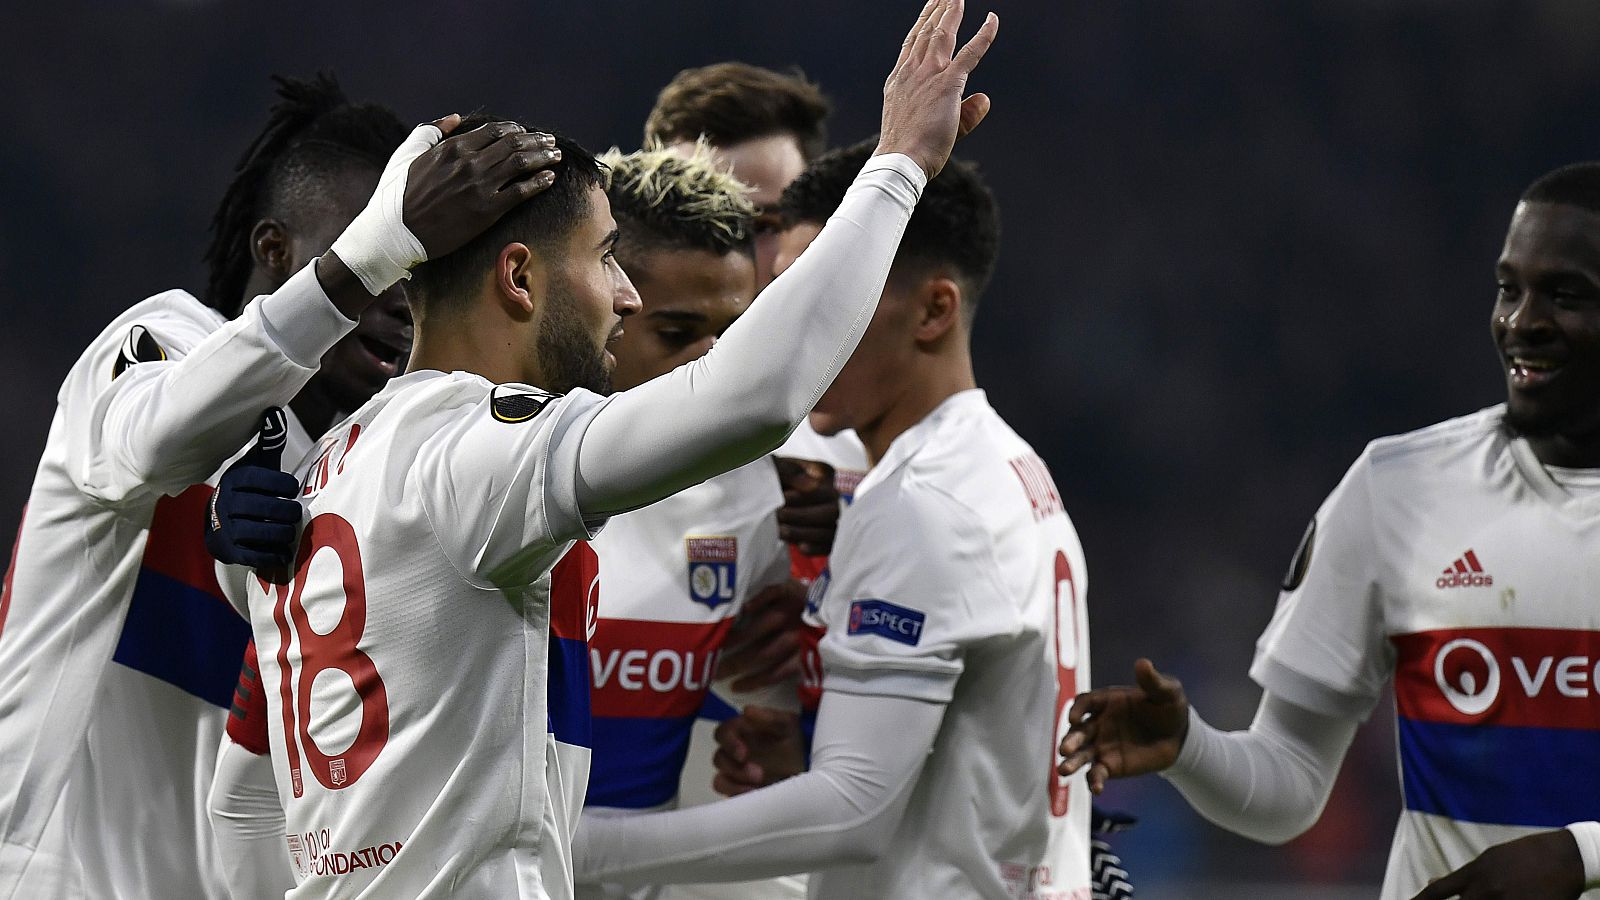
[1413,828,1584,900]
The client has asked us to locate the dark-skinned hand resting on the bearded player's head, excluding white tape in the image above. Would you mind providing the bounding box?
[317,114,562,319]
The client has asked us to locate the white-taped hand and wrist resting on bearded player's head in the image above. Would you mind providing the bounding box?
[317,115,562,297]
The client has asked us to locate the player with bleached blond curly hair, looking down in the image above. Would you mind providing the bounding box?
[579,143,806,900]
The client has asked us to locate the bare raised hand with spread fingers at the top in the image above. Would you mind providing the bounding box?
[877,0,1000,179]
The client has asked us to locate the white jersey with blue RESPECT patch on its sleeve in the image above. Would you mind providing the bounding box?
[811,389,1090,900]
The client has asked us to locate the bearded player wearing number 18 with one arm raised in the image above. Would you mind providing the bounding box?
[238,0,997,898]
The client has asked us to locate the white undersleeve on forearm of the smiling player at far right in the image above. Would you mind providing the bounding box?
[1162,693,1360,844]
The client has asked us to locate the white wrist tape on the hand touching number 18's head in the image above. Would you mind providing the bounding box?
[333,125,445,296]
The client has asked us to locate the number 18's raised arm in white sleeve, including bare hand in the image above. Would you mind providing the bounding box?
[578,0,998,517]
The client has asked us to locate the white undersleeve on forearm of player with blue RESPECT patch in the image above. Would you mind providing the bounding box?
[573,682,944,884]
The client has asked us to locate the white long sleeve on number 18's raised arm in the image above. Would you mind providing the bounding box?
[578,154,926,517]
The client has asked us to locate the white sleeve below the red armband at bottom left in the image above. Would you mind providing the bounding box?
[206,738,294,900]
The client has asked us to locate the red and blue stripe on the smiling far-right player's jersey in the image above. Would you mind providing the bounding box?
[1390,628,1600,828]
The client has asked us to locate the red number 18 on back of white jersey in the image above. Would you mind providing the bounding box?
[272,512,389,798]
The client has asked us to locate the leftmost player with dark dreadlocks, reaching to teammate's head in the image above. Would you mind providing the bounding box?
[0,71,547,898]
